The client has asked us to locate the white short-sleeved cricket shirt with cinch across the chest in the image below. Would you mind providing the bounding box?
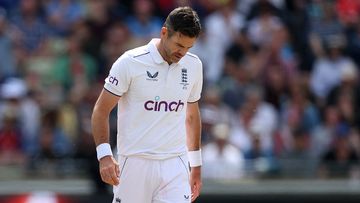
[104,39,203,159]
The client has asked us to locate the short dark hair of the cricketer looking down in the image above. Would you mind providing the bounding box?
[164,6,201,37]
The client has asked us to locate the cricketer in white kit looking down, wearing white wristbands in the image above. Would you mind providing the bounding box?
[92,7,203,203]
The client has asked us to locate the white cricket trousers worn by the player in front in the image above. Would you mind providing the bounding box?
[113,155,191,203]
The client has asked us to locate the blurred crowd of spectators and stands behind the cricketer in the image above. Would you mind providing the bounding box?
[0,0,360,203]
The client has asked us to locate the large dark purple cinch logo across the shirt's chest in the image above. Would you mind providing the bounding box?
[144,96,184,112]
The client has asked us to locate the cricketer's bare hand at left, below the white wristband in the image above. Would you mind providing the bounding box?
[99,156,120,185]
